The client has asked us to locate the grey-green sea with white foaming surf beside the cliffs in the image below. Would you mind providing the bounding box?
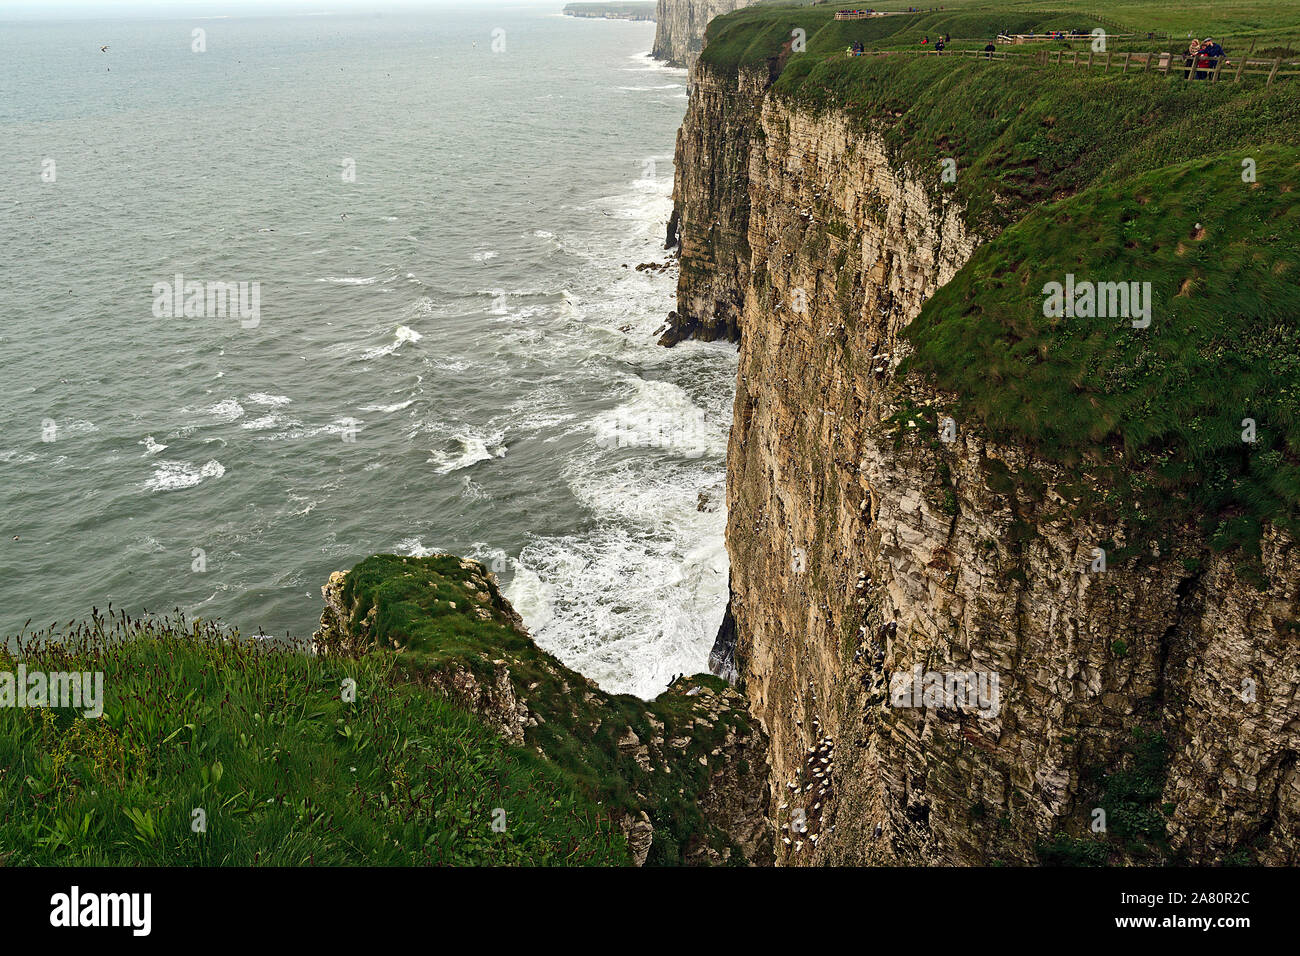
[0,3,736,696]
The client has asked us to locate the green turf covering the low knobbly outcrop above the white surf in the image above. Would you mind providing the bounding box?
[332,554,761,864]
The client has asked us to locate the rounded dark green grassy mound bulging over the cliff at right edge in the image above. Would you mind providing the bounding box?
[904,147,1300,550]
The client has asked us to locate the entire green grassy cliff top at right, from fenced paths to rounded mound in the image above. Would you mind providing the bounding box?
[701,0,1300,550]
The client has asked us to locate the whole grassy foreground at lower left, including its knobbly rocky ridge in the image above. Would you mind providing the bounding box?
[0,554,764,866]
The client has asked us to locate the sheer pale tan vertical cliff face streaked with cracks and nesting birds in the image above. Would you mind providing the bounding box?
[676,73,1300,864]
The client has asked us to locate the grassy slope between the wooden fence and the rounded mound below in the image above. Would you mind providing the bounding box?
[775,43,1300,234]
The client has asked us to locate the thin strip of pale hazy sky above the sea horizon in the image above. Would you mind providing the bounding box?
[0,0,567,21]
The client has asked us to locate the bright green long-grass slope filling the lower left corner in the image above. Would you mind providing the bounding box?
[0,618,627,866]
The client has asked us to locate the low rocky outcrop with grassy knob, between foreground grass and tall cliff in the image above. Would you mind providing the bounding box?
[315,555,772,865]
